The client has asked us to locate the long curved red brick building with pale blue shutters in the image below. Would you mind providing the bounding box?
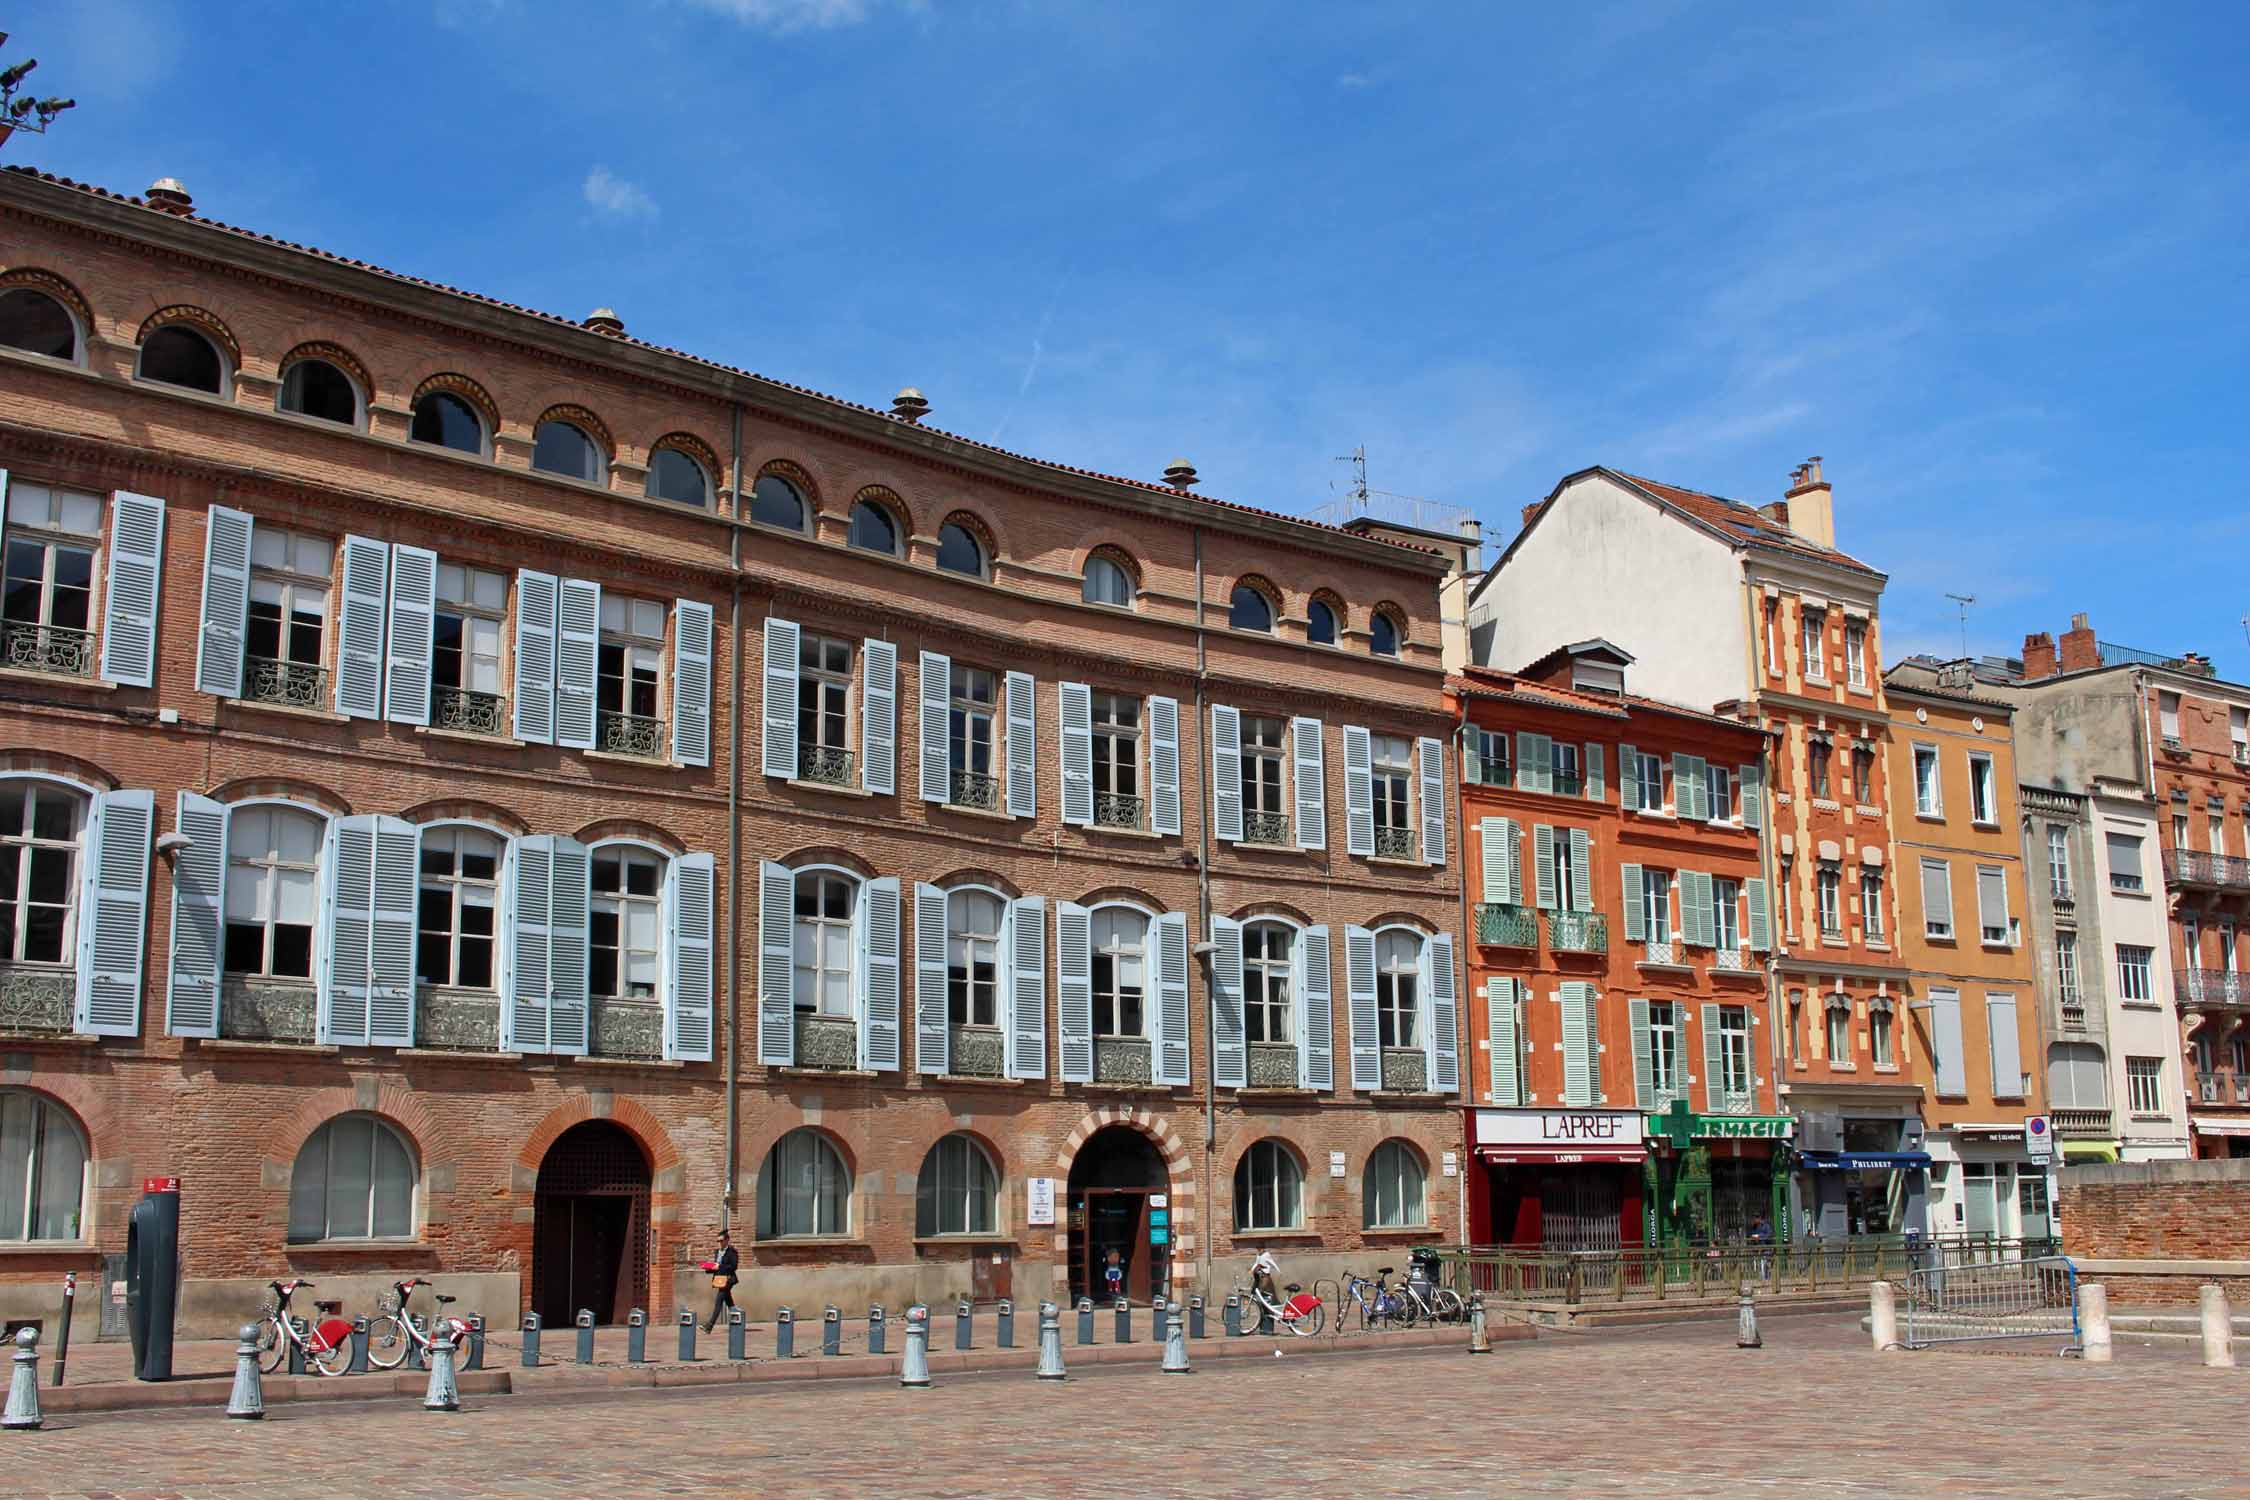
[0,171,1460,1331]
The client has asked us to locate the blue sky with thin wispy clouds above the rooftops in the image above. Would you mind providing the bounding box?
[17,0,2250,679]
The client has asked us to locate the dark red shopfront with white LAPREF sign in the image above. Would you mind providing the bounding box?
[1469,1109,1649,1250]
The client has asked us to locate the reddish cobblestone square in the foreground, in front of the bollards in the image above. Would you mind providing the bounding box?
[17,1318,2250,1500]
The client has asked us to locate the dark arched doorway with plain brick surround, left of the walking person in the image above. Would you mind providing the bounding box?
[531,1120,650,1327]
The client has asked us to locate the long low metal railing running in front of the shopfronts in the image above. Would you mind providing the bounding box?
[1438,1235,2059,1307]
